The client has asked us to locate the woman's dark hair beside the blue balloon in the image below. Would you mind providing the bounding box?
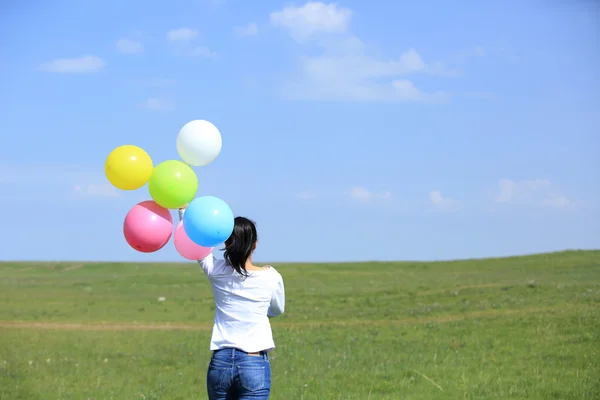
[223,217,258,276]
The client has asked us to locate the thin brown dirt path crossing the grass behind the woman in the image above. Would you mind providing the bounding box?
[0,305,594,332]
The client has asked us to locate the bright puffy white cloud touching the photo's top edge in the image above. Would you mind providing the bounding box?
[269,1,352,41]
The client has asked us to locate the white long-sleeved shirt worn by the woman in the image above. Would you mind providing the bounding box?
[179,210,285,353]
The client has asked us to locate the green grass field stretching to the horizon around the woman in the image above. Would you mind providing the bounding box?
[0,251,600,400]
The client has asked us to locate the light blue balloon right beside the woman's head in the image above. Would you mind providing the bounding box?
[183,196,234,247]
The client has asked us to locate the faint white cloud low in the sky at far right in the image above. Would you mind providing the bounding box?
[493,179,575,208]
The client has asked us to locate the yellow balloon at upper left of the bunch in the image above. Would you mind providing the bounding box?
[104,144,153,190]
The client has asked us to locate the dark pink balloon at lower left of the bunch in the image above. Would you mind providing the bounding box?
[123,200,173,253]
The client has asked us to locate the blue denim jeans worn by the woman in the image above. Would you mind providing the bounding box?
[206,349,271,400]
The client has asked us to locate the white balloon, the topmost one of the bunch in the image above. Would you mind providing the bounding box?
[176,119,223,167]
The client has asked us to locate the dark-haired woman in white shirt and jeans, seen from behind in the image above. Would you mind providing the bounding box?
[179,207,285,400]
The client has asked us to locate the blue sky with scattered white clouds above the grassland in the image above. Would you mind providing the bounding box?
[0,0,600,261]
